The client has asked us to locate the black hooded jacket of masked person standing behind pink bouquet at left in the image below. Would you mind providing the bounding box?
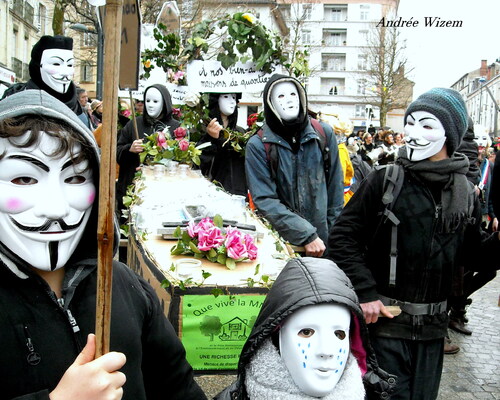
[116,84,180,216]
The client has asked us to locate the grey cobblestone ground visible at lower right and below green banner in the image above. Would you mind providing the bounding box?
[196,275,500,400]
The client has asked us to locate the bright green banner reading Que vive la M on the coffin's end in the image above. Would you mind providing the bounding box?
[181,295,266,370]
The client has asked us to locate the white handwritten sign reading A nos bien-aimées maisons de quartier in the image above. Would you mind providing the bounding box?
[187,60,281,93]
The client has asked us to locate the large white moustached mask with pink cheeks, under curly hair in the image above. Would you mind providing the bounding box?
[0,132,96,271]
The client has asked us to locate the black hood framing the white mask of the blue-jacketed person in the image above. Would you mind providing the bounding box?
[263,74,308,139]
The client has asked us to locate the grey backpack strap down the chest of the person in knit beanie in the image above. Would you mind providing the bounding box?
[382,164,404,287]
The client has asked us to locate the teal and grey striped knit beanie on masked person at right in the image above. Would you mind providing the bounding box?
[404,88,468,156]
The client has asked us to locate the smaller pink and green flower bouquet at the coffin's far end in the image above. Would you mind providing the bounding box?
[139,127,201,165]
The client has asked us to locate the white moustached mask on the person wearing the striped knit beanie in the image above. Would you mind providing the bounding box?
[405,111,446,161]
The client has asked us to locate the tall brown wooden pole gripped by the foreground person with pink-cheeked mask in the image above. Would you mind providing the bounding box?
[95,0,123,357]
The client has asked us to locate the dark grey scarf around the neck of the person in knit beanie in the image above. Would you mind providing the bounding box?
[398,147,473,233]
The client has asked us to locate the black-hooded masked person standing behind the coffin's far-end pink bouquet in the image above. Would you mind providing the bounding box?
[116,84,180,223]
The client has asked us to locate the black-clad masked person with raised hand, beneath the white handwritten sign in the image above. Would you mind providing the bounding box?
[200,93,247,196]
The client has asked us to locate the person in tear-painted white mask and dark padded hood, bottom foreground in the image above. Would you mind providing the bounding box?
[215,257,396,400]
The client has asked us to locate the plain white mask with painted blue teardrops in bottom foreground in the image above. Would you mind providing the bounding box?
[279,304,351,397]
